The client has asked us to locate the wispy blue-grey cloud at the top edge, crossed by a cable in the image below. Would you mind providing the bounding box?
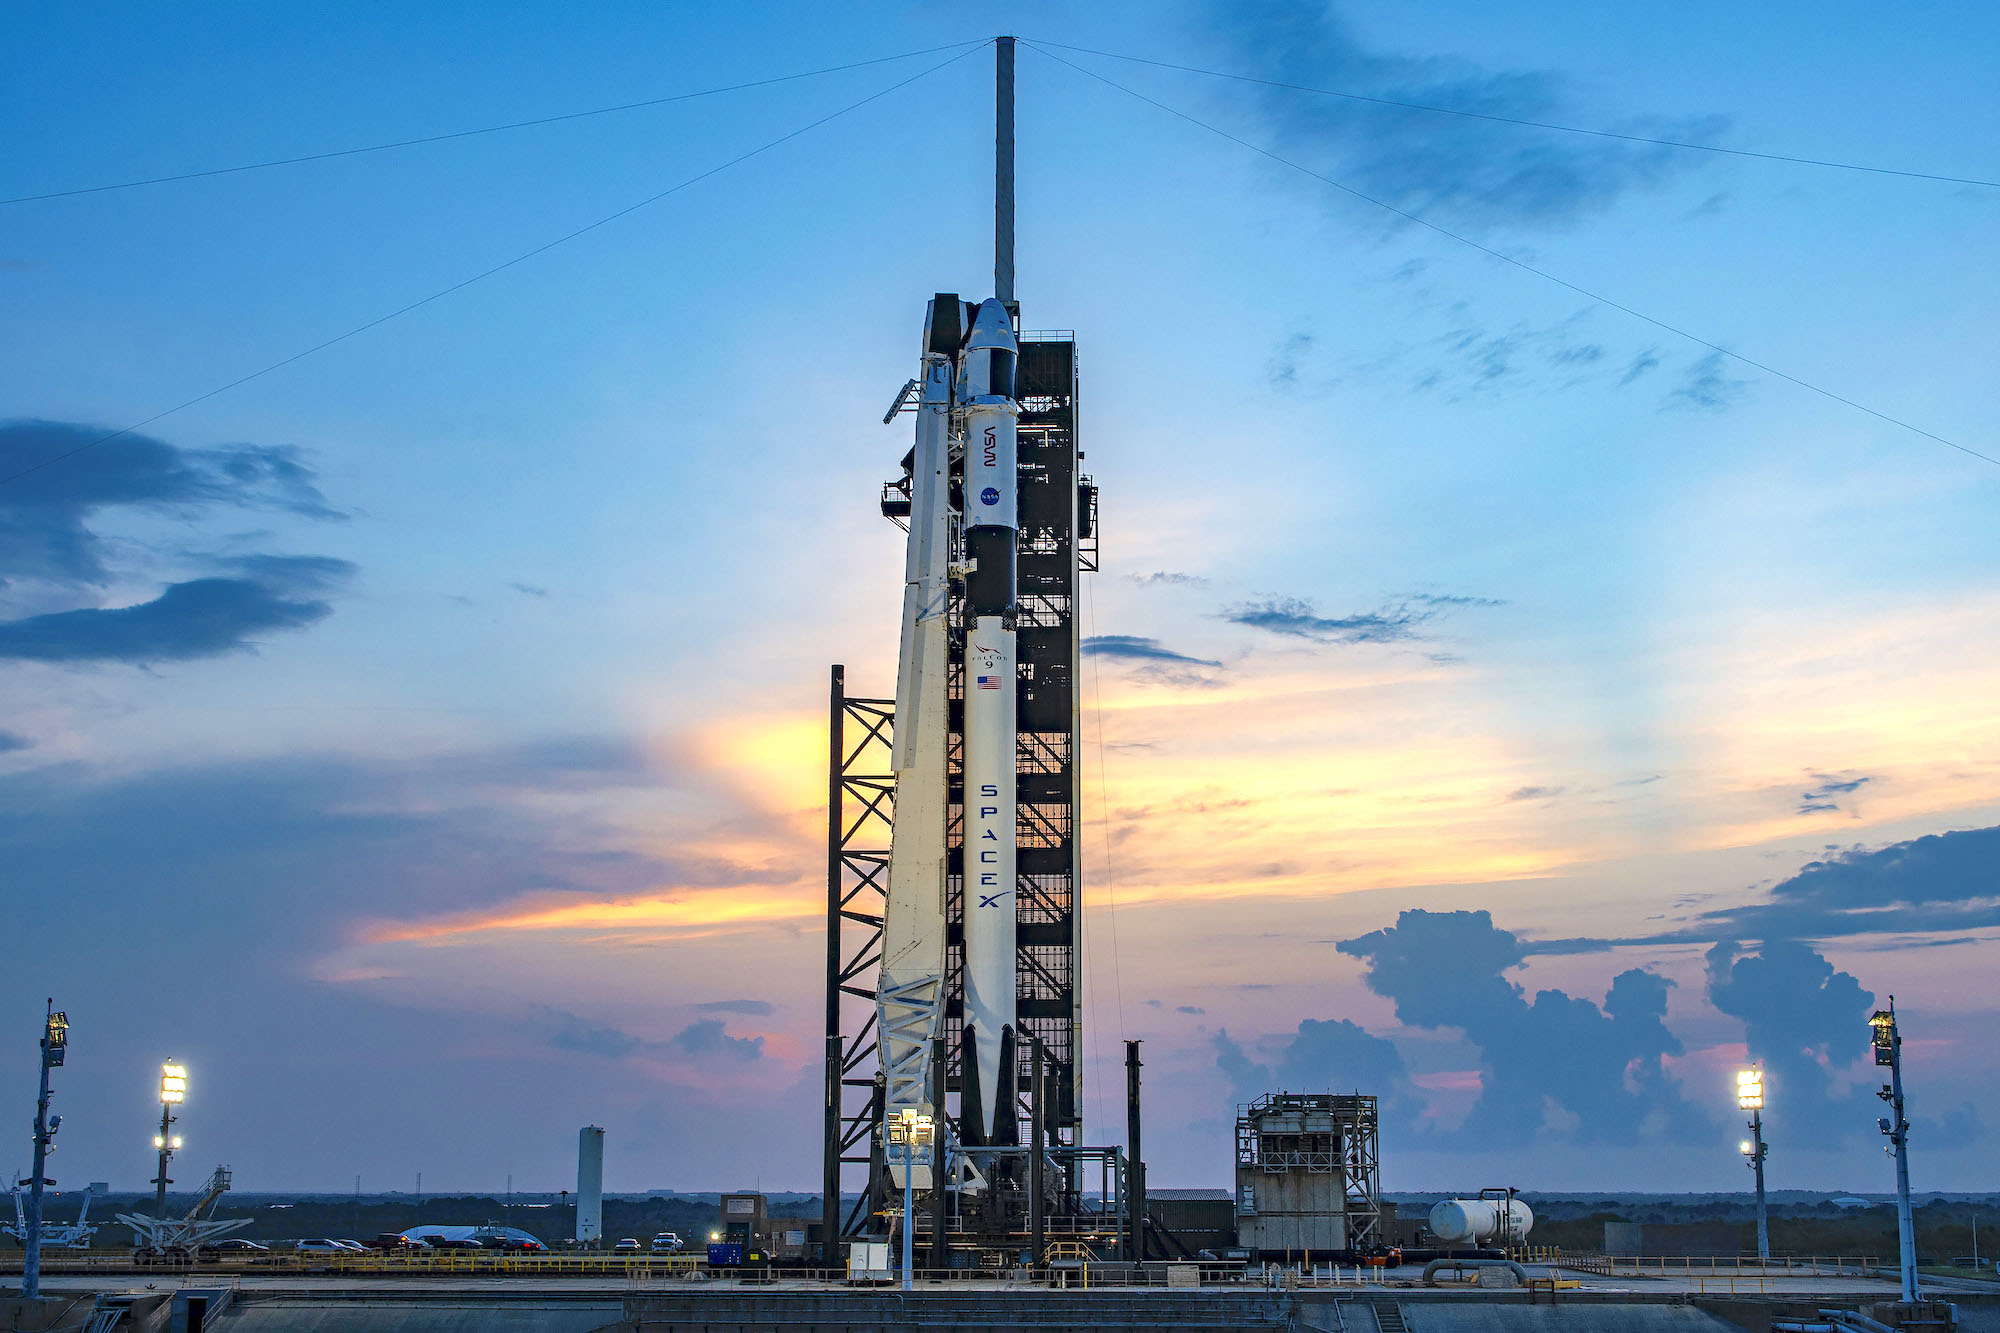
[1208,2,1726,230]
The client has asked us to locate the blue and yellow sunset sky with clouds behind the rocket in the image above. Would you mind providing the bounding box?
[0,0,2000,1193]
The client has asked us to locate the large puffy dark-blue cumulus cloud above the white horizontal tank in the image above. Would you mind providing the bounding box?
[1338,911,1712,1147]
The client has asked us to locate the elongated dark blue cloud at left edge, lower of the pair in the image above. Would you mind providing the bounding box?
[0,556,354,664]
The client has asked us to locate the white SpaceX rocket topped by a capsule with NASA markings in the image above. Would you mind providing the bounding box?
[958,298,1020,1143]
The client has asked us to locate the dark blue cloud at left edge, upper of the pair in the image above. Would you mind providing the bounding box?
[0,420,346,586]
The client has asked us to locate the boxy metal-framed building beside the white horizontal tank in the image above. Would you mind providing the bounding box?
[1236,1093,1382,1255]
